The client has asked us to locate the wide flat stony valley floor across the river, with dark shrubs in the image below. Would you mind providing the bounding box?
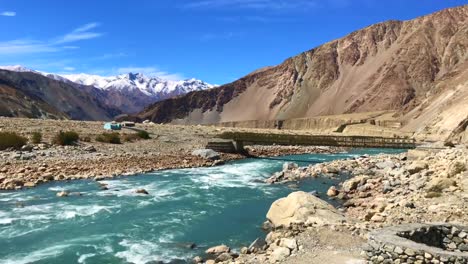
[0,118,340,190]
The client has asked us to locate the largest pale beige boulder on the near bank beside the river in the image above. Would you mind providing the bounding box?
[267,191,345,227]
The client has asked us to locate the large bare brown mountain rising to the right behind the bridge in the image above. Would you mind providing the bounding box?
[136,5,468,142]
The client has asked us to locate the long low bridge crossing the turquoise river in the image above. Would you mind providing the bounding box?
[207,132,416,152]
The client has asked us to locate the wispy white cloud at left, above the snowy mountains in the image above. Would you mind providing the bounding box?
[0,23,102,56]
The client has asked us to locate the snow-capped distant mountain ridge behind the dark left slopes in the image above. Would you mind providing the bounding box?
[0,65,215,113]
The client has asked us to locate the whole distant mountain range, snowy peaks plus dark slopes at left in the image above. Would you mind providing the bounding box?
[0,66,215,120]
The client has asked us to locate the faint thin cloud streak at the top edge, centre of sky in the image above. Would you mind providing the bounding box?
[184,0,317,10]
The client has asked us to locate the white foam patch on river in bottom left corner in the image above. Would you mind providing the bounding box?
[0,245,70,264]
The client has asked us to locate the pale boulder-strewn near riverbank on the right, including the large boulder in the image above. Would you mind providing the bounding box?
[199,146,468,263]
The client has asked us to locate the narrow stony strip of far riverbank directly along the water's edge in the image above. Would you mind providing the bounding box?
[0,144,343,190]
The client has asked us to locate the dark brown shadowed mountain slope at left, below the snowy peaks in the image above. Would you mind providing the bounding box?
[0,70,121,120]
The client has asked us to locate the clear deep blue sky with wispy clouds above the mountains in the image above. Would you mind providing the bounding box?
[0,0,468,84]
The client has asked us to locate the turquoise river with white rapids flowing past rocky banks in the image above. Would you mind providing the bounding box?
[0,149,401,264]
